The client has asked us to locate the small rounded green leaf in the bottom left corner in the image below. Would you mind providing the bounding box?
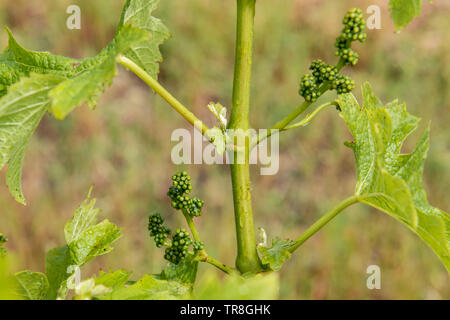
[14,271,49,300]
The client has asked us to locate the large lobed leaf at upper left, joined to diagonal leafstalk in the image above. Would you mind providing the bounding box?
[0,0,169,204]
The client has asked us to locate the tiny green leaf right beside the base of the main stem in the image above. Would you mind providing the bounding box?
[258,237,293,271]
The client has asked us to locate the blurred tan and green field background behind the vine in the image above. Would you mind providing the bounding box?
[0,0,450,299]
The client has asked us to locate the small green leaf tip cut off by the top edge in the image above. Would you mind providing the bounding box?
[389,0,433,31]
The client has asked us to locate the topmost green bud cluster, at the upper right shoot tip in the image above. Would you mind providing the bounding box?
[335,8,367,66]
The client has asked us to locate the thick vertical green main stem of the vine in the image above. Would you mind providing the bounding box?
[229,0,261,273]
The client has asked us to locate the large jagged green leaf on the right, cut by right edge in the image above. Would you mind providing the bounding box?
[338,83,450,270]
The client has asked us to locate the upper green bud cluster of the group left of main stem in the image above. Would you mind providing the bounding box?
[167,172,205,217]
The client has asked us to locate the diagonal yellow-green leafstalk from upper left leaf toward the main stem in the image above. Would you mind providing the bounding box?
[116,55,209,136]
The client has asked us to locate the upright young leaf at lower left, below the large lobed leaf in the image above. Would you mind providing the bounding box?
[46,192,121,300]
